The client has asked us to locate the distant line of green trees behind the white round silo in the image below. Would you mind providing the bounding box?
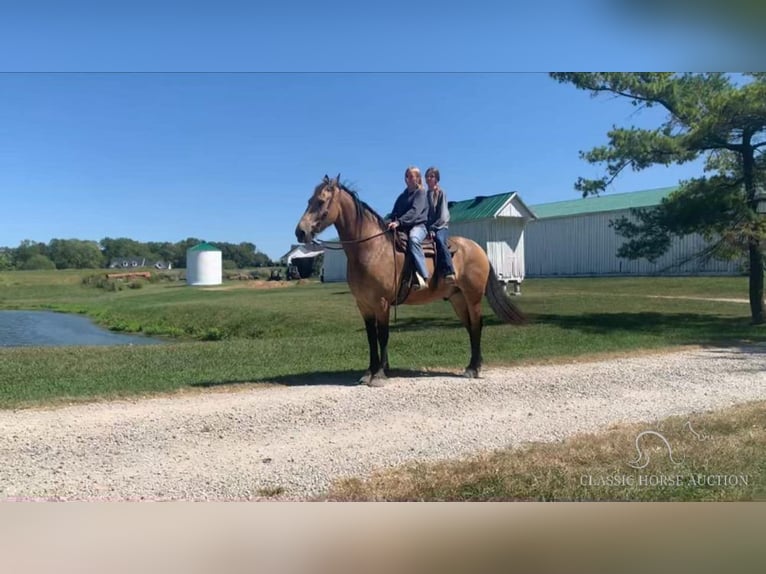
[0,237,274,271]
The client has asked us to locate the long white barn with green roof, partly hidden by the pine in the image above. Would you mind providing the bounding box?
[525,187,742,277]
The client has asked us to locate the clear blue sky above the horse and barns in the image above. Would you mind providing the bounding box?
[0,0,748,258]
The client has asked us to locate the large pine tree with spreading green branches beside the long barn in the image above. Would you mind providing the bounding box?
[551,73,766,324]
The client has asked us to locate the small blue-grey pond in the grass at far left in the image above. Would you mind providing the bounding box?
[0,311,162,347]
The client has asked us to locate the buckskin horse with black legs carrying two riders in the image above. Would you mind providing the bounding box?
[295,174,526,386]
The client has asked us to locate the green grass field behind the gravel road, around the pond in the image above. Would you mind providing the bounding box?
[0,271,766,408]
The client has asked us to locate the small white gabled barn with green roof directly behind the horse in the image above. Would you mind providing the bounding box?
[322,192,535,292]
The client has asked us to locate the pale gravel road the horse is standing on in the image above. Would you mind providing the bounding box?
[0,346,766,500]
